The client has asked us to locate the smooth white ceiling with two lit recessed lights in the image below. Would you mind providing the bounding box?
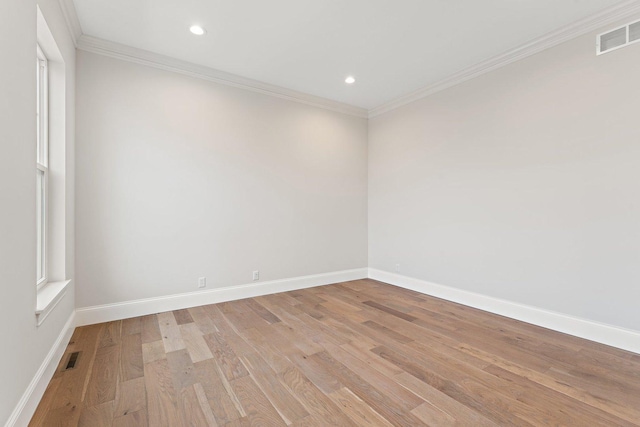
[74,0,619,109]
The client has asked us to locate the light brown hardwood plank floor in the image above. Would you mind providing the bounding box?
[30,280,640,427]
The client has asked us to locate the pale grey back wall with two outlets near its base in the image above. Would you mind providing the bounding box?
[76,51,367,307]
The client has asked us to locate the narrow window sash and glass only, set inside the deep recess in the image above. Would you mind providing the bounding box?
[36,46,49,287]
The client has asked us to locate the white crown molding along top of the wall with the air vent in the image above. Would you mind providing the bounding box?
[369,0,640,118]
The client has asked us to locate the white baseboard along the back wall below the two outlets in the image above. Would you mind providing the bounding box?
[76,268,367,326]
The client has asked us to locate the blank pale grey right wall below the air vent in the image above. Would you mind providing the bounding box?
[369,19,640,330]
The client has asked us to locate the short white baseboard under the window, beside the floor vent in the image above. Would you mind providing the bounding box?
[5,312,75,427]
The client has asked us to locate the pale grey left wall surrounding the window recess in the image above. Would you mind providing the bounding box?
[0,0,75,424]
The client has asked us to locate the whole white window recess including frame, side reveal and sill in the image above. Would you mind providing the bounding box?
[34,5,72,326]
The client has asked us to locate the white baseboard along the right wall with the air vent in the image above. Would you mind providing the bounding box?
[369,268,640,354]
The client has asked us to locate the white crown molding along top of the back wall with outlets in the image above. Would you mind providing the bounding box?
[77,34,368,118]
